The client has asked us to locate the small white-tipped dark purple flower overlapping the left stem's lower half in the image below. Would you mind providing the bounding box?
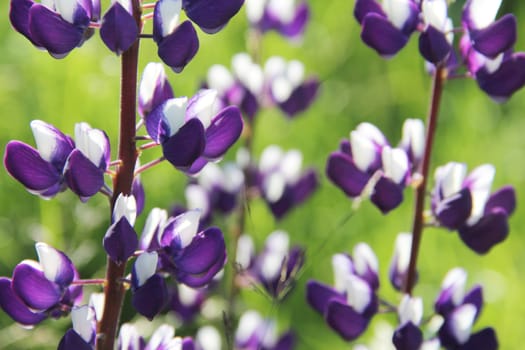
[103,194,138,265]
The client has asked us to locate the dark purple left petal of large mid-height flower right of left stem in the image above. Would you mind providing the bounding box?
[162,118,206,168]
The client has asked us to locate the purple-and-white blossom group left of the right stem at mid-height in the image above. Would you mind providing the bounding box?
[326,119,425,214]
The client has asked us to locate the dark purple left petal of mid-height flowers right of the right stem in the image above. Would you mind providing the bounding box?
[434,188,472,230]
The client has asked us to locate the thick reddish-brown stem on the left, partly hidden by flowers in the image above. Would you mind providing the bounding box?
[97,0,142,350]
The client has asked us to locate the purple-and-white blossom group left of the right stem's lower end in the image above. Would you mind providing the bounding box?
[306,243,379,340]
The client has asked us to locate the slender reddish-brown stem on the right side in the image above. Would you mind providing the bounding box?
[403,65,446,295]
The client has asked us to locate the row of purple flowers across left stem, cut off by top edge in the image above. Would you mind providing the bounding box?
[9,0,243,72]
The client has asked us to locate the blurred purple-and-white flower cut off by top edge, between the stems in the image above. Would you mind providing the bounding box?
[246,0,310,40]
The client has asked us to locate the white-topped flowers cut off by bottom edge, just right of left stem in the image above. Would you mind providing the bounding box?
[118,323,195,350]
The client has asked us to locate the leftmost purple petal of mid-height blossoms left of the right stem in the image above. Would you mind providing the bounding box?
[326,152,370,197]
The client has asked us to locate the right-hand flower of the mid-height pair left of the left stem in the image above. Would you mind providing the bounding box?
[65,123,110,201]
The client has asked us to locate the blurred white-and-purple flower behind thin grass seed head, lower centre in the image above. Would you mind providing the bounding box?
[236,231,304,299]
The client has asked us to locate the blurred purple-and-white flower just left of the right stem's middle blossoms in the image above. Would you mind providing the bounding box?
[257,145,318,219]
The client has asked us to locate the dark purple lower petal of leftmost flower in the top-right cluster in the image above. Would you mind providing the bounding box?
[361,13,408,57]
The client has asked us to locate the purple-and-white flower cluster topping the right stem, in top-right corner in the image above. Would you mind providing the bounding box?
[354,0,525,101]
